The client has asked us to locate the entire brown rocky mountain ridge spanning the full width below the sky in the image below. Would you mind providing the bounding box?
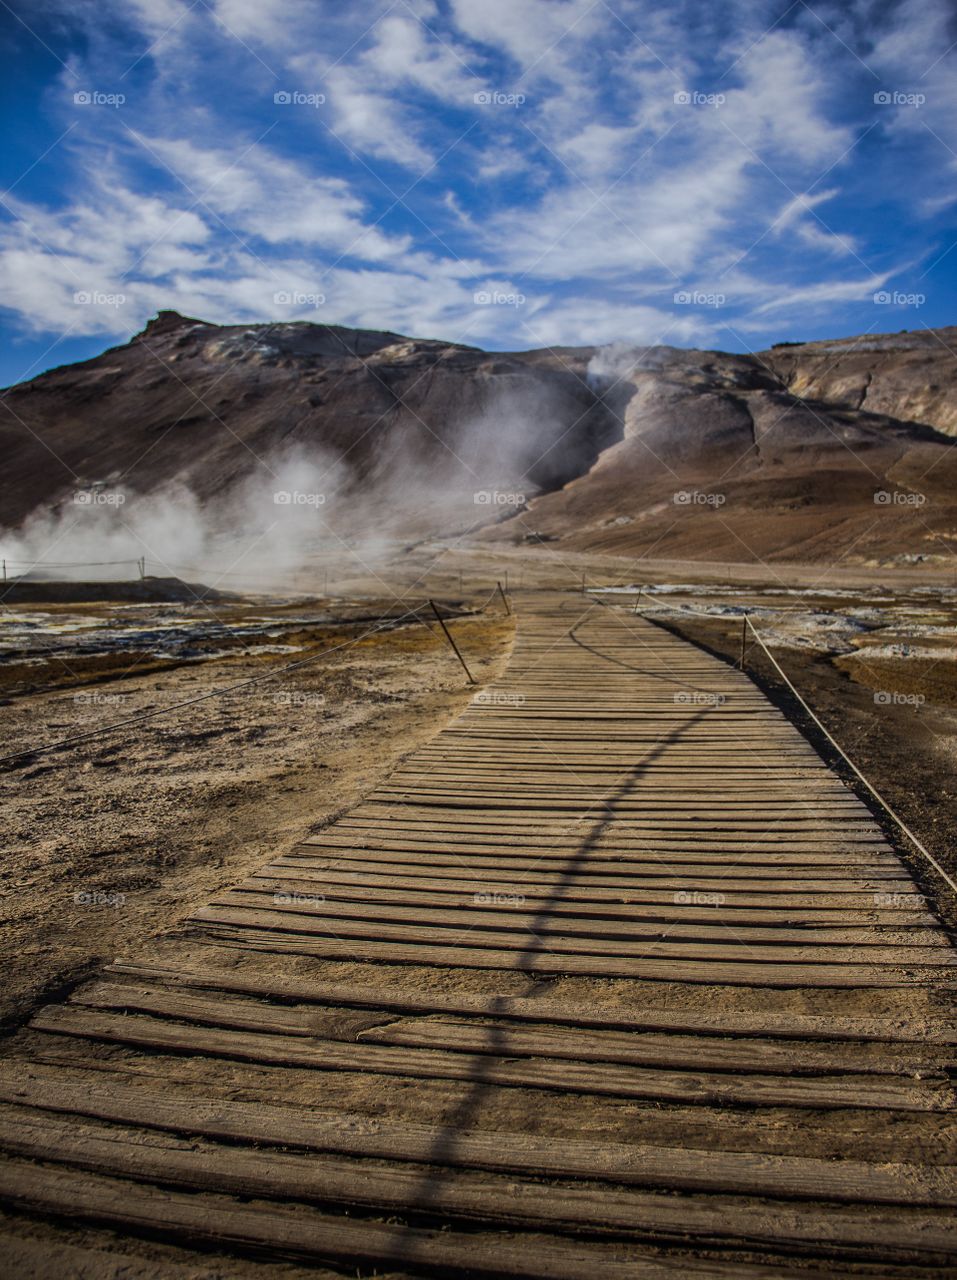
[0,312,957,566]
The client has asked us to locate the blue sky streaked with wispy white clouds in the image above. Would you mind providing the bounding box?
[0,0,957,384]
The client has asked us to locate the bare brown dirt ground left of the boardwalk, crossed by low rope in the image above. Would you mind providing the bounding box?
[0,608,513,1029]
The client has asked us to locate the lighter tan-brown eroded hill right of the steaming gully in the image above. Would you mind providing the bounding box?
[489,330,957,568]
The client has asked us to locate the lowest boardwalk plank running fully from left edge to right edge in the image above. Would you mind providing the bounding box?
[0,1108,953,1258]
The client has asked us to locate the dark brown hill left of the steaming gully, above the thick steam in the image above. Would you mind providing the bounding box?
[0,311,610,531]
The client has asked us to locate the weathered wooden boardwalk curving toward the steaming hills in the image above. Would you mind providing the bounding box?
[0,594,957,1280]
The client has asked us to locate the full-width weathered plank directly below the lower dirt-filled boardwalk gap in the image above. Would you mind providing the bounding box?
[0,1065,957,1208]
